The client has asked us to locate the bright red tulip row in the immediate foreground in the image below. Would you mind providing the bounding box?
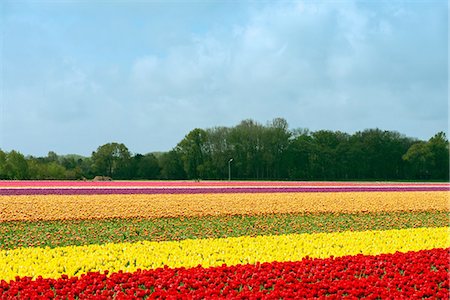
[0,248,450,299]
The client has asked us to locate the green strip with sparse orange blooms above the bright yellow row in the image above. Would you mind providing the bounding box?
[0,211,450,250]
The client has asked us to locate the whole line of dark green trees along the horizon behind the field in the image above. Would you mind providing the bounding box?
[0,118,450,181]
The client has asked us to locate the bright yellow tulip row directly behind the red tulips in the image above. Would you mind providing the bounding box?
[0,227,450,280]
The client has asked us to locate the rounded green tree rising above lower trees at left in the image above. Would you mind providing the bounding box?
[92,143,131,179]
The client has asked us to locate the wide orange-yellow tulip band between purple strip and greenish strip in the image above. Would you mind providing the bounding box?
[0,191,449,222]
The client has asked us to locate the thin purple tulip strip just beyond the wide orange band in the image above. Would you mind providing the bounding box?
[0,186,450,196]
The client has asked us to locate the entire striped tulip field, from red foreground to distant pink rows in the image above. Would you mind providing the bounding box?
[0,181,450,299]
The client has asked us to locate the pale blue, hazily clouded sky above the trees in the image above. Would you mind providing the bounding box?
[0,0,449,156]
